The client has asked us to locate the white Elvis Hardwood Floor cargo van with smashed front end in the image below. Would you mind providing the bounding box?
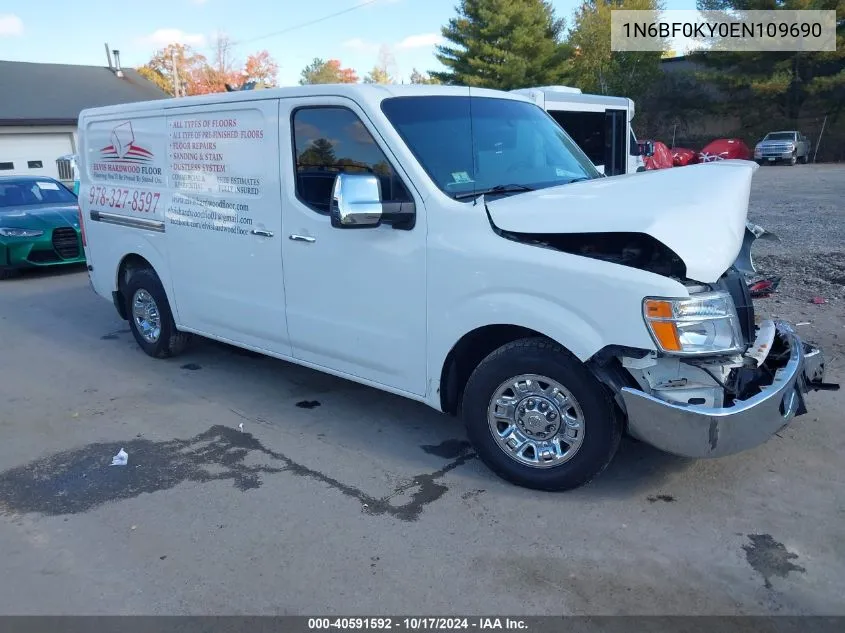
[79,85,829,490]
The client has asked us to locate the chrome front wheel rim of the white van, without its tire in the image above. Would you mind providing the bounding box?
[487,374,584,468]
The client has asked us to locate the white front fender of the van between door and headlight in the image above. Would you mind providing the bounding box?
[428,202,689,390]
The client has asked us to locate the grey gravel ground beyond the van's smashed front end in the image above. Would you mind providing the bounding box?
[749,165,845,372]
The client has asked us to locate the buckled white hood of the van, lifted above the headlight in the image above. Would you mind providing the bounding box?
[487,160,758,283]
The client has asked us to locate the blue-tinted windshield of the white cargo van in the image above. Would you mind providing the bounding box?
[381,96,601,198]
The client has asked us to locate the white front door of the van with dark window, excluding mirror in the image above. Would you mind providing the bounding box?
[279,97,426,395]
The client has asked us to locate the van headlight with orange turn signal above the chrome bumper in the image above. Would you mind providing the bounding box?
[643,292,743,355]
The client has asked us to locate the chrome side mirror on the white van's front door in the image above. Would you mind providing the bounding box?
[329,173,417,231]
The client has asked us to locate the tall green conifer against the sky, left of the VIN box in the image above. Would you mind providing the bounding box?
[430,0,569,90]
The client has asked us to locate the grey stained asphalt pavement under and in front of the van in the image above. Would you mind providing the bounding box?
[0,168,845,615]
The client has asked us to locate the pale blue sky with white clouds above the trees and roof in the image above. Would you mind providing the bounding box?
[0,0,695,85]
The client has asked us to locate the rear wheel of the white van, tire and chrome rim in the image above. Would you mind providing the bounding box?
[122,268,191,358]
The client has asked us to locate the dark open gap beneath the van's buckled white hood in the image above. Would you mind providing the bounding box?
[499,230,686,279]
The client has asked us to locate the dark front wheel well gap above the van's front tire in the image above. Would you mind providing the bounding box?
[440,325,543,415]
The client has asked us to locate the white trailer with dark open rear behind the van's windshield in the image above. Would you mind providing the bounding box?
[511,86,645,176]
